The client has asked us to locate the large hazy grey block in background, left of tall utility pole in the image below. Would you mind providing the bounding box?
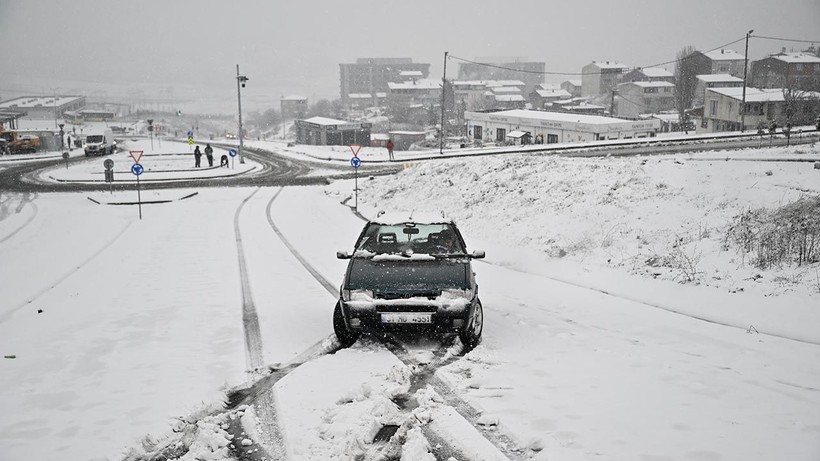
[339,58,430,105]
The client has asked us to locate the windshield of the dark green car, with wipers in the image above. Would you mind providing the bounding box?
[356,223,465,255]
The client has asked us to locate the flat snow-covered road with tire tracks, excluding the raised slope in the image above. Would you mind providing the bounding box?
[0,168,820,461]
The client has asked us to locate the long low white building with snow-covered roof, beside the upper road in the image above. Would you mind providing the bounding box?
[465,109,661,144]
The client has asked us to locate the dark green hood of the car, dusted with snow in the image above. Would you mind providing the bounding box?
[347,253,470,296]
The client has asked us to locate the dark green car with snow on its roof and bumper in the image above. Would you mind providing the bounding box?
[333,213,484,347]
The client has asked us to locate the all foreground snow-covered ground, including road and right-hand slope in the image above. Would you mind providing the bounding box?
[0,137,820,461]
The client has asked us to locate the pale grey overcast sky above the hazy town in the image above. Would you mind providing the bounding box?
[0,0,820,110]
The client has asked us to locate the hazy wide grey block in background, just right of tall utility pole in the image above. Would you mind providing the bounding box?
[457,57,547,94]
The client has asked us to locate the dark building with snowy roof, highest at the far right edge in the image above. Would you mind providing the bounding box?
[749,51,820,91]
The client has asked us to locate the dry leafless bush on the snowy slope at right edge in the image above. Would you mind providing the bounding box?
[726,196,820,269]
